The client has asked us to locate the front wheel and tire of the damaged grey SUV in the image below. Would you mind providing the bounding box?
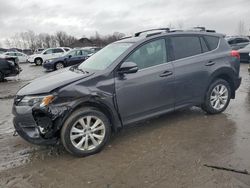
[61,107,111,157]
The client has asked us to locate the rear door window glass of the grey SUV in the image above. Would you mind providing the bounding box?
[171,36,202,60]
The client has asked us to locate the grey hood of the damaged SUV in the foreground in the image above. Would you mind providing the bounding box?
[17,68,94,96]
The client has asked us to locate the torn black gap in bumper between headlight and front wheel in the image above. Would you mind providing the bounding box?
[32,105,72,139]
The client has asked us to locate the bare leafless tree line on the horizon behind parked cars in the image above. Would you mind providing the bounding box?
[5,30,125,51]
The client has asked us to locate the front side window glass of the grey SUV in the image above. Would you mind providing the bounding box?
[126,39,167,69]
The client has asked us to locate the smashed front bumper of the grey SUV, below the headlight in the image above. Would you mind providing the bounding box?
[13,104,71,145]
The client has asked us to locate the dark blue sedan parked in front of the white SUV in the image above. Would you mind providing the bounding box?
[43,48,93,70]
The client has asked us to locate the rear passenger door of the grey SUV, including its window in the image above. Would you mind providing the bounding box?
[171,35,213,108]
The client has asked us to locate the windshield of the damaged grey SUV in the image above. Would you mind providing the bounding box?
[79,43,132,70]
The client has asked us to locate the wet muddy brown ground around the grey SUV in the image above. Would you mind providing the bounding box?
[0,64,250,188]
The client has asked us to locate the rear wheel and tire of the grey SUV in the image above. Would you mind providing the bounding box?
[201,79,231,114]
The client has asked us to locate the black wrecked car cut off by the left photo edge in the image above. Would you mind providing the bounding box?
[0,57,22,82]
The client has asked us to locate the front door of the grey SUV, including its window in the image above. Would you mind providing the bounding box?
[115,39,175,124]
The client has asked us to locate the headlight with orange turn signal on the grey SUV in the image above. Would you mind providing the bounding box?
[18,95,54,107]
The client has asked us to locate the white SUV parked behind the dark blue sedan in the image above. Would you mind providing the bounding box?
[28,47,70,65]
